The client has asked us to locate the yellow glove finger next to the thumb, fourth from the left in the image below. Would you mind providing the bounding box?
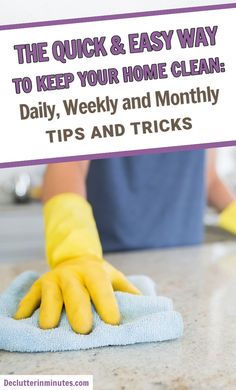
[85,269,120,325]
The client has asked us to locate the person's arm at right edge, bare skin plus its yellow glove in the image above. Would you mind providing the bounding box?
[207,150,236,235]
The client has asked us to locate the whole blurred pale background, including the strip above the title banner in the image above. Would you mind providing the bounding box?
[0,0,236,261]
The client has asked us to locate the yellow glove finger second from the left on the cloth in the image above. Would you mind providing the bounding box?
[39,279,63,329]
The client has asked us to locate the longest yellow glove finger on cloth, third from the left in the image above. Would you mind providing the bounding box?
[61,276,93,334]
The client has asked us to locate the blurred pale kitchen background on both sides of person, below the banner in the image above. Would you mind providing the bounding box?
[0,147,236,261]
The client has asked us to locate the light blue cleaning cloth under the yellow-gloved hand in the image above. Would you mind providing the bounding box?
[0,271,183,352]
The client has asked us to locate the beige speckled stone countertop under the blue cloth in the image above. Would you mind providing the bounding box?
[0,242,236,390]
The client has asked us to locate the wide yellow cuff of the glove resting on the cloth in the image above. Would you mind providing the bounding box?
[43,193,102,268]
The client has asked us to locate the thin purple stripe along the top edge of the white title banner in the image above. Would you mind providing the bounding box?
[0,3,236,30]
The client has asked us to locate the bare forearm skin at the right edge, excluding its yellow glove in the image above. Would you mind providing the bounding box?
[207,149,235,213]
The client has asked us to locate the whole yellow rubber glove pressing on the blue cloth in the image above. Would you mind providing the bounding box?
[14,194,140,334]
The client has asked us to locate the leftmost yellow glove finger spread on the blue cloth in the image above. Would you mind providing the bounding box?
[14,280,41,320]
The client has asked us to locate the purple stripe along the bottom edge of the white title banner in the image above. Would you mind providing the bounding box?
[0,140,236,168]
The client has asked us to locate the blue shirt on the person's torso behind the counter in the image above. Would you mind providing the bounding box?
[87,150,205,251]
